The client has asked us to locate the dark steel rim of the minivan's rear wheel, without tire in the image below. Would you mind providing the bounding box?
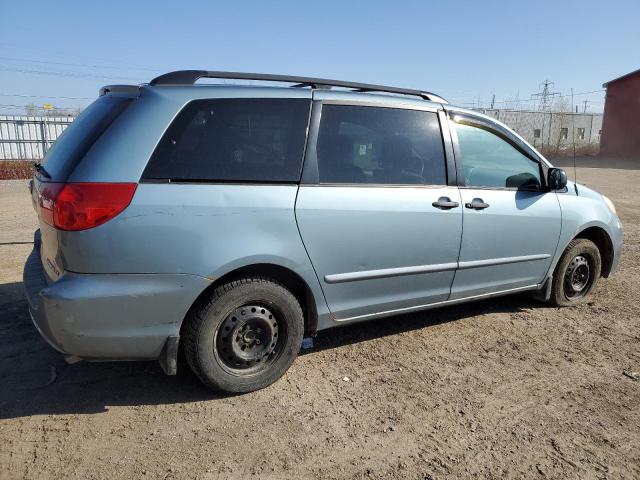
[213,304,281,375]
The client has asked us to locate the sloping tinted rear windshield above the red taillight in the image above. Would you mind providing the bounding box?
[44,95,132,181]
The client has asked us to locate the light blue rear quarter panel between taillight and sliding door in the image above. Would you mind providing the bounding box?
[60,183,328,322]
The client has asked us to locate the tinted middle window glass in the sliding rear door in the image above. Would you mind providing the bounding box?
[316,105,446,185]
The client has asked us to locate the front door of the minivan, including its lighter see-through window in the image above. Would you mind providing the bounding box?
[451,116,561,299]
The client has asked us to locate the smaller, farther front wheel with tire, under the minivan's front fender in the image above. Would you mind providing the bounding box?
[551,238,602,307]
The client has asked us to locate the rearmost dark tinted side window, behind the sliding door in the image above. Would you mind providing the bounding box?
[143,98,311,182]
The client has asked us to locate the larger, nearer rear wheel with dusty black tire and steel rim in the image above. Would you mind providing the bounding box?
[182,276,304,393]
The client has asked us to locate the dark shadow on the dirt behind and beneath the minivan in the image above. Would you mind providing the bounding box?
[0,283,544,419]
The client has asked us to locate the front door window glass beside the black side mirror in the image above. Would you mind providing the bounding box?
[455,124,541,189]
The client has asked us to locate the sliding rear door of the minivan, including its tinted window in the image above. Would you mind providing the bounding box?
[296,101,462,320]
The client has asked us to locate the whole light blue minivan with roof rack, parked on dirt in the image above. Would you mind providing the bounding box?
[24,70,622,392]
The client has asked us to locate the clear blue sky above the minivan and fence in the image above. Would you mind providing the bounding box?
[0,0,640,112]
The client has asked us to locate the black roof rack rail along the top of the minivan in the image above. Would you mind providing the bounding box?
[149,70,447,103]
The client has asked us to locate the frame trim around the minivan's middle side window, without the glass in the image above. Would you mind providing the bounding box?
[300,100,450,188]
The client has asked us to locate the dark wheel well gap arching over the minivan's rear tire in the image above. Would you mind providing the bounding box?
[183,263,318,336]
